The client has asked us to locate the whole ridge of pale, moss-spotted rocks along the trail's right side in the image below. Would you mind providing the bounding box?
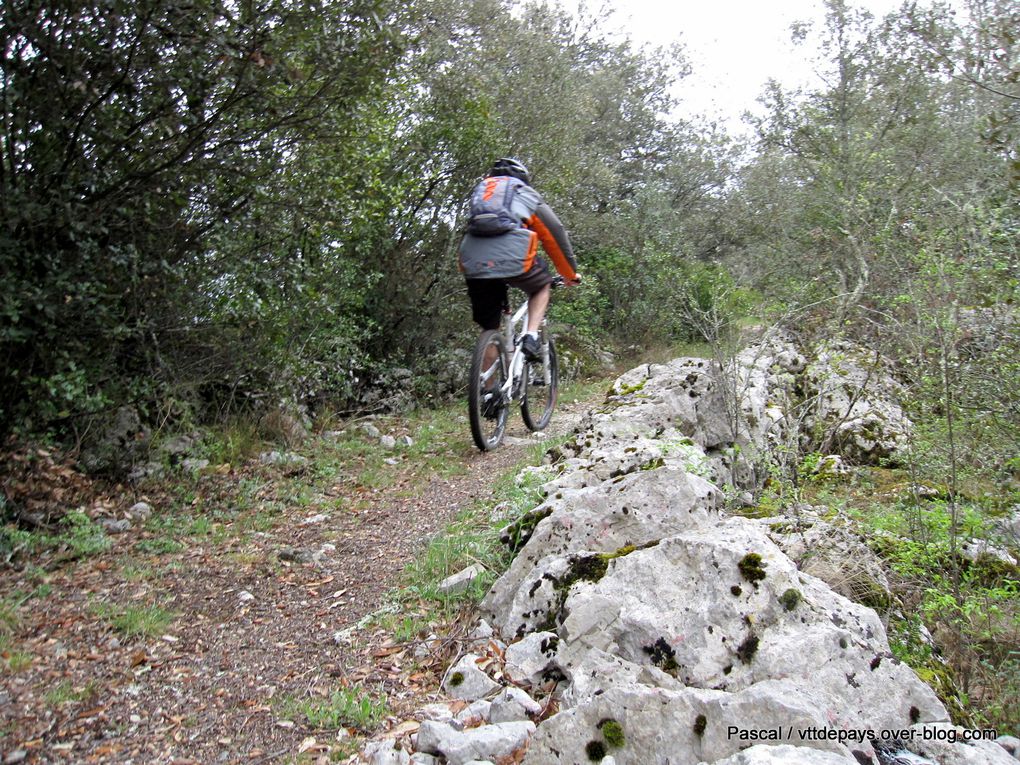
[366,338,1015,765]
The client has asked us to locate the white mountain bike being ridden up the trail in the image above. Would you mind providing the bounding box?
[467,277,564,452]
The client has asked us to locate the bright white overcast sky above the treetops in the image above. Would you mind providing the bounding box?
[562,0,934,133]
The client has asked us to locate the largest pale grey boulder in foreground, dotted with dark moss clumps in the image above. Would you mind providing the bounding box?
[558,518,948,730]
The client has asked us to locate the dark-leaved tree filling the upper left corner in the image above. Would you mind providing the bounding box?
[0,0,396,429]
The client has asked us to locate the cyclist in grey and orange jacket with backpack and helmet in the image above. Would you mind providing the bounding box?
[460,157,580,373]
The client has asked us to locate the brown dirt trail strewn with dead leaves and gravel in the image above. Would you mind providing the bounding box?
[0,402,588,765]
